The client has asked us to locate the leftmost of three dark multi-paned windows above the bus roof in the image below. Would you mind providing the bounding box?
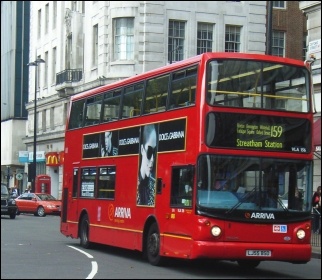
[168,20,186,63]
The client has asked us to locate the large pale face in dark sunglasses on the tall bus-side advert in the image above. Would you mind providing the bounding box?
[141,130,157,177]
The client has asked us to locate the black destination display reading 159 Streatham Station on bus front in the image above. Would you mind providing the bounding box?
[206,112,311,153]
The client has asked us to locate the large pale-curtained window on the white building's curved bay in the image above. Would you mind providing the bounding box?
[114,18,134,60]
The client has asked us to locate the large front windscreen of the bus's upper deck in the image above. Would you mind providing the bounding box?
[207,60,310,112]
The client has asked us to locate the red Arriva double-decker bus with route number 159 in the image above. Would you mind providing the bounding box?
[60,53,313,267]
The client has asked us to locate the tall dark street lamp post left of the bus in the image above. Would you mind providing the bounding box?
[27,58,45,192]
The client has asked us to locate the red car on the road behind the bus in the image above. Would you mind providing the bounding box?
[15,193,61,217]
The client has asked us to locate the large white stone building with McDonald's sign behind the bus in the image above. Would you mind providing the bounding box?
[23,1,267,198]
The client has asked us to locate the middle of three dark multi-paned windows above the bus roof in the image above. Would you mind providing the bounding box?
[197,23,213,54]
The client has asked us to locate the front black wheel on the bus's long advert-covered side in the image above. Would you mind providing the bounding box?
[146,223,163,266]
